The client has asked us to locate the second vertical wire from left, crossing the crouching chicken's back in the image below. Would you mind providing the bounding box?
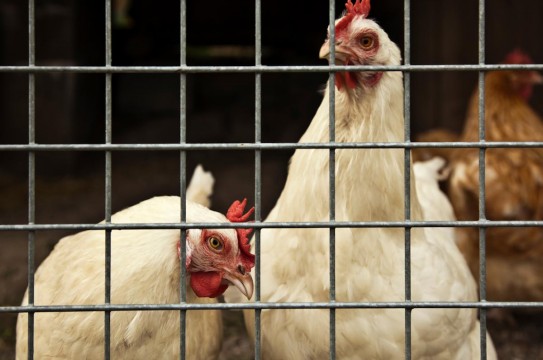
[104,0,112,360]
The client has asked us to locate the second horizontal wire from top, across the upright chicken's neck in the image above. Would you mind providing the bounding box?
[0,141,543,151]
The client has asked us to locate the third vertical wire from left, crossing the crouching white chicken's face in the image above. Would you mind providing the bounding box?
[179,0,187,360]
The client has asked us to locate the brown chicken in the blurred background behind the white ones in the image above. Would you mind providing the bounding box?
[449,50,543,301]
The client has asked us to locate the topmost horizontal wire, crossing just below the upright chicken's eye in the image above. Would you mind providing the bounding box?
[0,64,543,74]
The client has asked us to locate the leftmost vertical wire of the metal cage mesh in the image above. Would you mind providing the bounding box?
[27,0,36,359]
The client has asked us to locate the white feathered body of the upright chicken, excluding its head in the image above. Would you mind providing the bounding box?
[254,84,492,359]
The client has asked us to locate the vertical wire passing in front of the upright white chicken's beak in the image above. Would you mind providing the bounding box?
[328,0,336,360]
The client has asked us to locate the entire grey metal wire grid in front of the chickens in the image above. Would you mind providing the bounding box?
[0,0,543,359]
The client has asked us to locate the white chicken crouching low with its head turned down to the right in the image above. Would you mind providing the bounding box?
[16,170,254,359]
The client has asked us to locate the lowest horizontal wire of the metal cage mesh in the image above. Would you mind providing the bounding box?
[0,301,543,313]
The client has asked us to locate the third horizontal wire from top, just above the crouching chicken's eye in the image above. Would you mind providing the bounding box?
[0,220,543,231]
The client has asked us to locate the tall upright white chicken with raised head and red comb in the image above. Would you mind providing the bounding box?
[234,0,495,360]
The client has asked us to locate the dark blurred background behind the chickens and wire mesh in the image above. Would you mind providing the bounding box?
[0,0,543,359]
